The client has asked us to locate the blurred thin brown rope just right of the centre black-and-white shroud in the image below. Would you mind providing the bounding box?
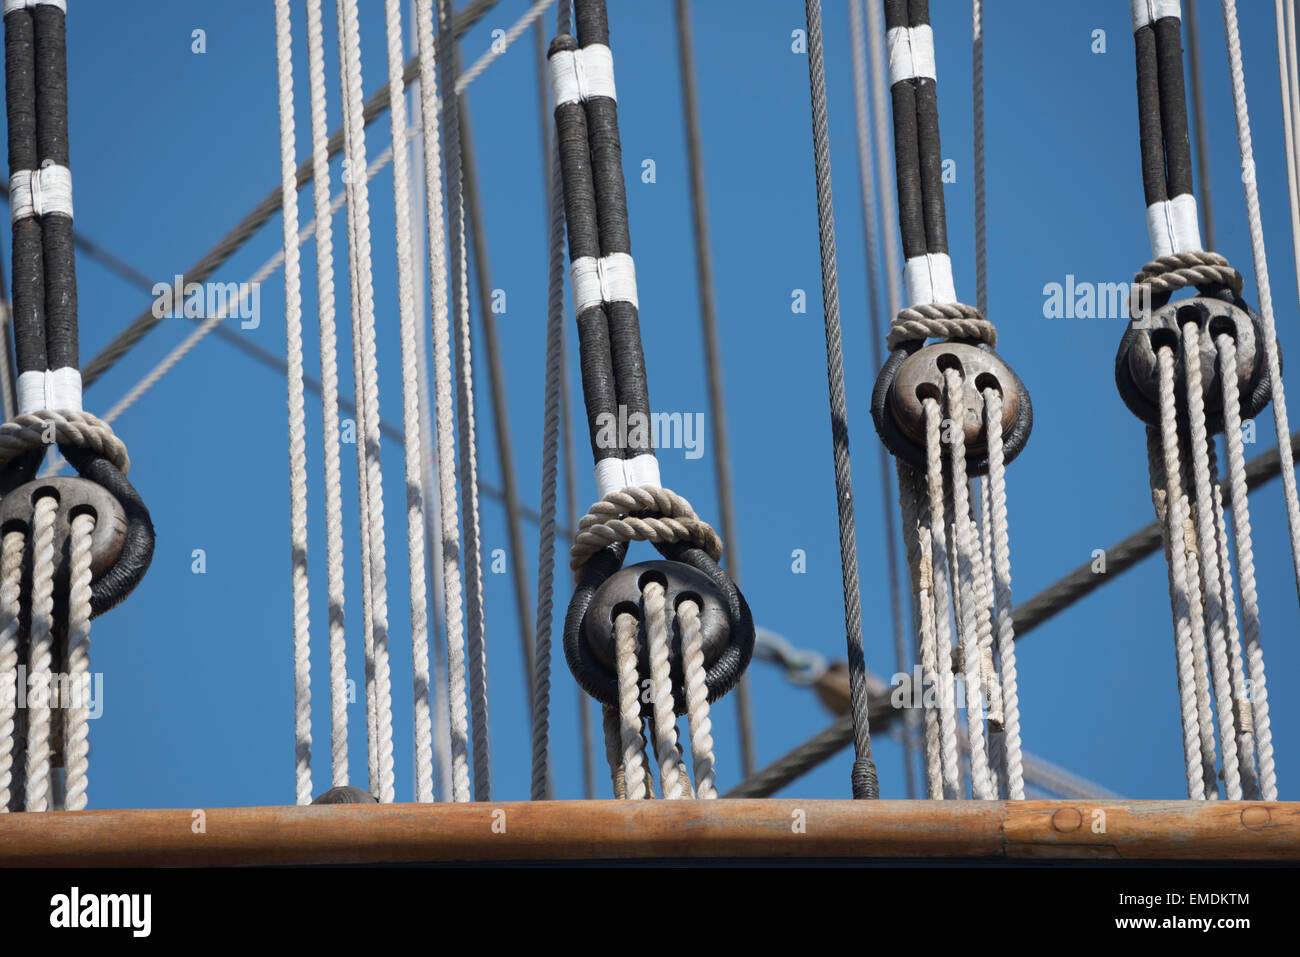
[676,0,759,787]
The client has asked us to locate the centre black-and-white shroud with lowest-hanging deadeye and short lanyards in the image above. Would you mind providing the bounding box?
[546,0,754,798]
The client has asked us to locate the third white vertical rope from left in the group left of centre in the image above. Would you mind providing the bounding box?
[338,0,394,804]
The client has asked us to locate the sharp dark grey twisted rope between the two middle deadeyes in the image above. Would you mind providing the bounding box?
[803,0,880,798]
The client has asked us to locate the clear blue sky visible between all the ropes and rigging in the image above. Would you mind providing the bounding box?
[17,0,1300,807]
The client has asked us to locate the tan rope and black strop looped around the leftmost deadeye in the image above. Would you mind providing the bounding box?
[0,410,155,616]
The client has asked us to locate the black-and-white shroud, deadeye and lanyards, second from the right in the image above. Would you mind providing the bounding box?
[871,0,1034,800]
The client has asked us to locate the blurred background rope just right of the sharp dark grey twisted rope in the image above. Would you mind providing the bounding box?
[847,0,917,798]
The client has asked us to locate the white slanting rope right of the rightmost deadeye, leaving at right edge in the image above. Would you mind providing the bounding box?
[1223,0,1300,605]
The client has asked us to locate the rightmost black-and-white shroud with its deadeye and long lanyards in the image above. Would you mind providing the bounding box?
[1115,0,1284,800]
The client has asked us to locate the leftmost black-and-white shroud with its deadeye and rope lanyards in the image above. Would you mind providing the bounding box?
[0,0,153,811]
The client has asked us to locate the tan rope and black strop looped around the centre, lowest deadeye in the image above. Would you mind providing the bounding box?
[564,486,754,706]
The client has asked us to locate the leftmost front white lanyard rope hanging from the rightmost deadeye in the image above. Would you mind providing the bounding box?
[1148,347,1206,800]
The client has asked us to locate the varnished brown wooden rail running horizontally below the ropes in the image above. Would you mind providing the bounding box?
[0,800,1300,867]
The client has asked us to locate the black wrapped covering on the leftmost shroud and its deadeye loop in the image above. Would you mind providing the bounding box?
[0,3,155,615]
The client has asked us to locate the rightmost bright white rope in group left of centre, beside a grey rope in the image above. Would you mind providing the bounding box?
[416,0,469,801]
